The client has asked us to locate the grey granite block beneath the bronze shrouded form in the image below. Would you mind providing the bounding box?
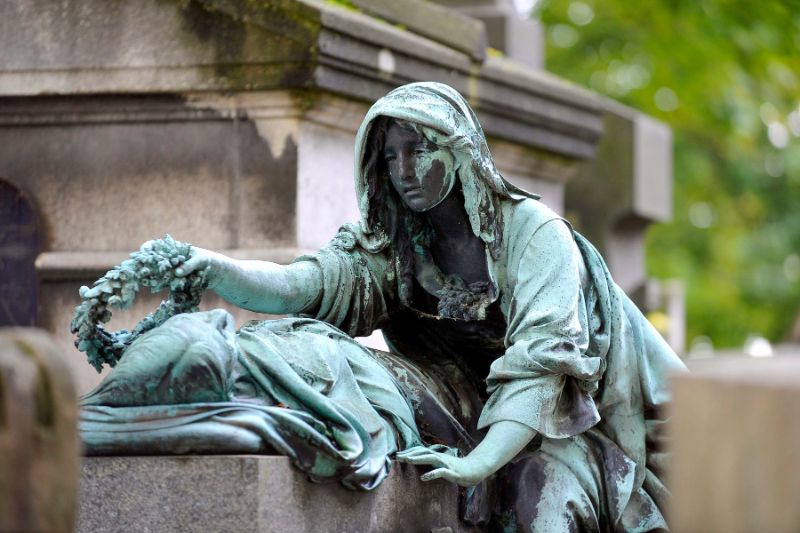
[77,455,471,533]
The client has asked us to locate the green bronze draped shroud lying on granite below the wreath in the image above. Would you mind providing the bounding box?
[80,311,422,490]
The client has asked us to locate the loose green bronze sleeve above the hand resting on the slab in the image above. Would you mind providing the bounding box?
[479,219,603,438]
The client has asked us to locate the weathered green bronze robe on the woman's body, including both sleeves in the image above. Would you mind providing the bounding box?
[300,197,685,531]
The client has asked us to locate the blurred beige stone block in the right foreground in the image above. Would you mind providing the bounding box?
[670,357,800,533]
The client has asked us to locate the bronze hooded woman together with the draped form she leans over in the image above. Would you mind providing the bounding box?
[82,83,683,531]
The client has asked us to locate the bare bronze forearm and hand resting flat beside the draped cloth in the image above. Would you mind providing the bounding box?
[397,420,536,487]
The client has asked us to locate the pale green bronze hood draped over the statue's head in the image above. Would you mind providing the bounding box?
[355,82,539,258]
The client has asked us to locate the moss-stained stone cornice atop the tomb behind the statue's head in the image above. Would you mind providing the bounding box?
[0,0,603,159]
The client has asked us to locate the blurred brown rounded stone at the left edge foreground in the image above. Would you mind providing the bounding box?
[0,328,78,532]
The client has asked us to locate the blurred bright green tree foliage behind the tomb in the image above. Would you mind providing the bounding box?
[532,0,800,347]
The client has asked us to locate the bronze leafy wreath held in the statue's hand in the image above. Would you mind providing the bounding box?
[70,235,207,372]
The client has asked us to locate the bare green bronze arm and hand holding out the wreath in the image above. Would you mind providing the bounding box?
[175,246,322,314]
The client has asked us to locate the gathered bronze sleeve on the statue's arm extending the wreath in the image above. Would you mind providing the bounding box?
[297,226,396,337]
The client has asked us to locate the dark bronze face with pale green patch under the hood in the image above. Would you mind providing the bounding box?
[383,122,456,212]
